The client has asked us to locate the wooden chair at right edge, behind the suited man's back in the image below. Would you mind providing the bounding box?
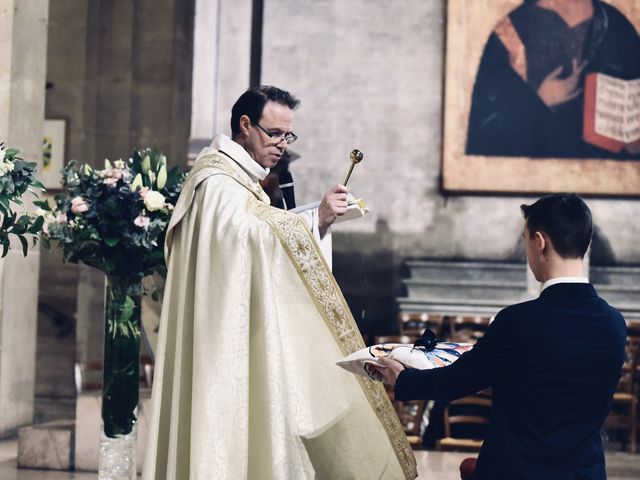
[604,341,640,453]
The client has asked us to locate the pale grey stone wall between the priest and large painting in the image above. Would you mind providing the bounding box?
[262,0,640,330]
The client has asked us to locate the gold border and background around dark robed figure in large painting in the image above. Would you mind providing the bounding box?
[442,0,640,196]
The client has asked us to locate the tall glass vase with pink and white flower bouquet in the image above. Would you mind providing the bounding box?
[37,149,186,479]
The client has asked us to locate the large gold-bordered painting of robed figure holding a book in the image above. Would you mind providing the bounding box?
[442,0,640,196]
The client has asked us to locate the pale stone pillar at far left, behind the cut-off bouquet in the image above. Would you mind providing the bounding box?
[0,0,49,437]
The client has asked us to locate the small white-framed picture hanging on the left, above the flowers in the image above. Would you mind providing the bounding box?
[38,118,67,191]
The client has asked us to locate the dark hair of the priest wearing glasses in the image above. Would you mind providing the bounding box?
[231,85,300,137]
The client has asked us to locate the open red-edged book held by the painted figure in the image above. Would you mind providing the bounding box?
[583,73,640,153]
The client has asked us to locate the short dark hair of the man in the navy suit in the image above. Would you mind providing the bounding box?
[520,193,593,258]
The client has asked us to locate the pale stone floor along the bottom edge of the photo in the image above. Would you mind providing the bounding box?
[0,439,640,480]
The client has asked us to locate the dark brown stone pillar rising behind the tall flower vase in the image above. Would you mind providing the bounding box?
[94,0,194,169]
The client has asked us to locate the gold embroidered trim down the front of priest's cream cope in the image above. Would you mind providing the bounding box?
[247,197,418,479]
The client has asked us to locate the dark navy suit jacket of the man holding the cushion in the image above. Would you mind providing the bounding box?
[395,283,627,480]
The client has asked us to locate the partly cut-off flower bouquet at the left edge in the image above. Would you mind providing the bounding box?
[0,143,44,257]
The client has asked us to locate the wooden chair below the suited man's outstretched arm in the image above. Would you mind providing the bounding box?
[436,394,491,452]
